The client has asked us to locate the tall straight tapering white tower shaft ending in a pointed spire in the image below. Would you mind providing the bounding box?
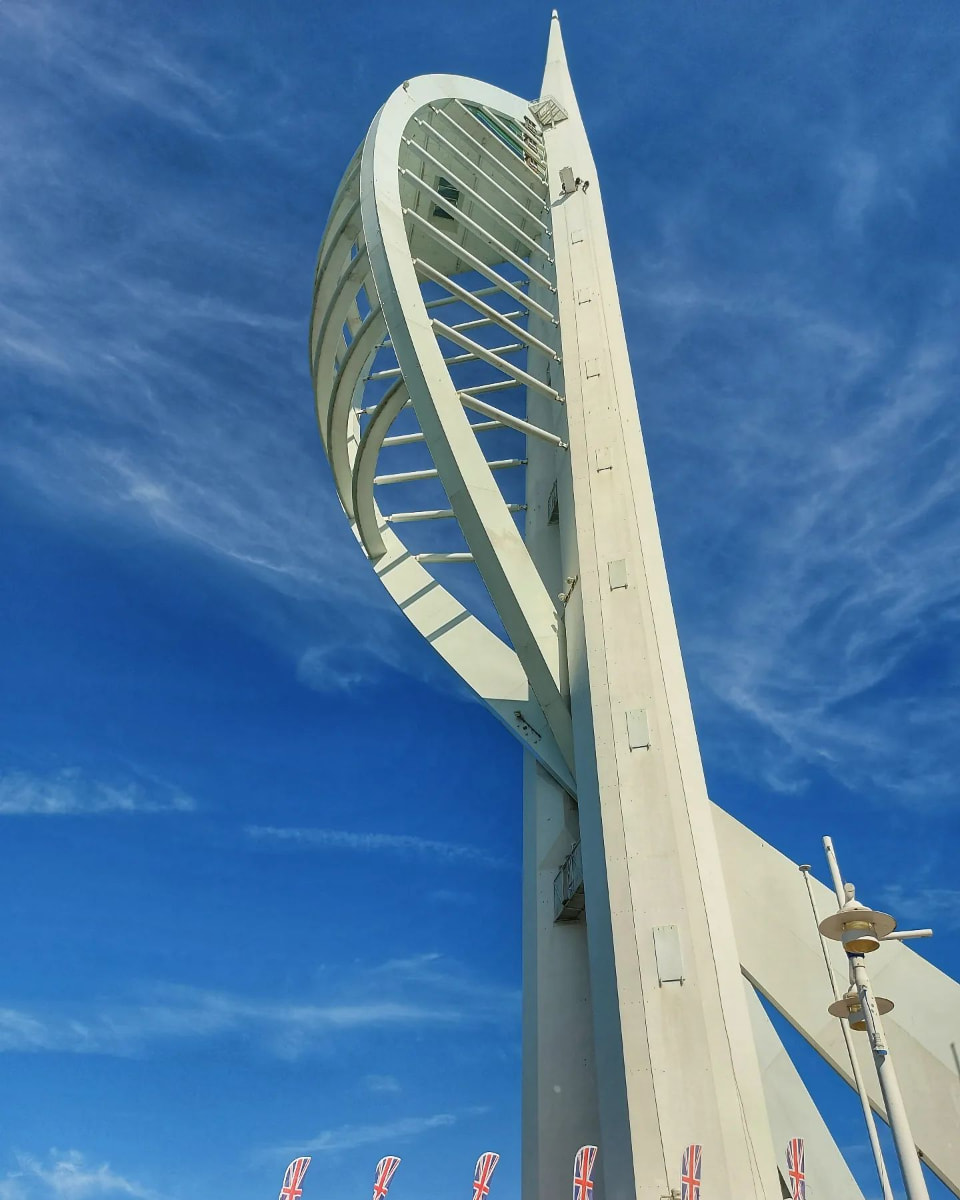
[520,19,779,1200]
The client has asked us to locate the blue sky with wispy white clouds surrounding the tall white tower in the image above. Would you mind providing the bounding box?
[0,0,960,1200]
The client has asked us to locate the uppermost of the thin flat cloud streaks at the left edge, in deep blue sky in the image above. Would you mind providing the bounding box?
[0,768,197,816]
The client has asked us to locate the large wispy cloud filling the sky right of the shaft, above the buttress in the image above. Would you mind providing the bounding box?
[600,6,960,808]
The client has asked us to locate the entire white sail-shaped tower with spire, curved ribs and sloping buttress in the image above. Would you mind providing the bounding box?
[310,14,960,1200]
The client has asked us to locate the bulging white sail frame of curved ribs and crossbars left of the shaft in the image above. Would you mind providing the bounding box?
[310,76,574,792]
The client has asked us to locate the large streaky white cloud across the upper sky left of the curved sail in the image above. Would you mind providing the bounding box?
[0,0,385,607]
